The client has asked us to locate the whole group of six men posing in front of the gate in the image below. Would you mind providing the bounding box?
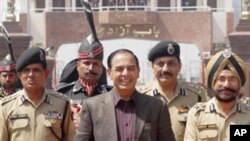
[0,2,250,141]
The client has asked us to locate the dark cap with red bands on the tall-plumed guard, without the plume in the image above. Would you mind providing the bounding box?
[78,34,103,60]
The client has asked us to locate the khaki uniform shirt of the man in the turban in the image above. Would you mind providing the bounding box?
[184,98,250,141]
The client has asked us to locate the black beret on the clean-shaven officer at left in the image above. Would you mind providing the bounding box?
[16,48,47,72]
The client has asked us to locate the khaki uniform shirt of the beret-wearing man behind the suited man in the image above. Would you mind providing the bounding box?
[138,81,208,141]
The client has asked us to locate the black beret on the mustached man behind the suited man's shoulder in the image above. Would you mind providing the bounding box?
[148,41,180,62]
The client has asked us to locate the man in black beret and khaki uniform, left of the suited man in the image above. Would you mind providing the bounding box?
[0,48,75,141]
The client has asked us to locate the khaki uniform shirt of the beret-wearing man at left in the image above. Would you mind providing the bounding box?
[0,90,75,141]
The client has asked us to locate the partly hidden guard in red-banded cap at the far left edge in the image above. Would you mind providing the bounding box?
[0,54,18,99]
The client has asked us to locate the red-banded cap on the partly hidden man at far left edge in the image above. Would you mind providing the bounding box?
[0,54,16,72]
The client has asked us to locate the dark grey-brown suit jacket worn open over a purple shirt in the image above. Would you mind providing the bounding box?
[74,89,175,141]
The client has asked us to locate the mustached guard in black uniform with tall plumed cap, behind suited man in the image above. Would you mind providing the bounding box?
[57,2,112,128]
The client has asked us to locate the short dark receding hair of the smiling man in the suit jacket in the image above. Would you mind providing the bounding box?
[107,49,139,68]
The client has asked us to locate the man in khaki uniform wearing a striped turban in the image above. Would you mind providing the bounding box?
[184,49,250,141]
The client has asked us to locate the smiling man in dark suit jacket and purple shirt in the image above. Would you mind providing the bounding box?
[75,49,175,141]
